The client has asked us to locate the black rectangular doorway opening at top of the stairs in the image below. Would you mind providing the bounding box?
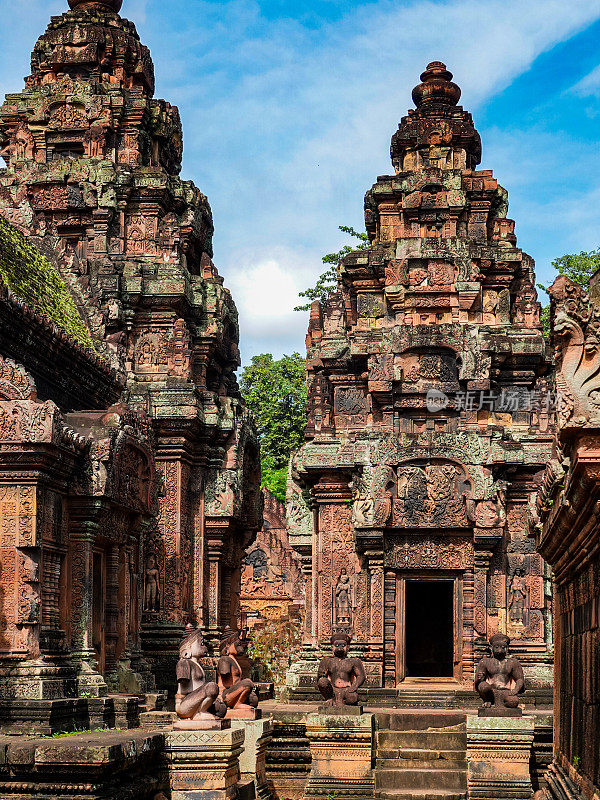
[406,580,454,678]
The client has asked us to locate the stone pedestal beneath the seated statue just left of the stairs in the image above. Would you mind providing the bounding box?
[305,706,374,800]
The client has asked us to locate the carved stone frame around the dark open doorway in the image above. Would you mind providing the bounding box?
[396,571,463,685]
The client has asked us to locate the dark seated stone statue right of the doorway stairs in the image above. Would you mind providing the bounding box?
[475,633,525,716]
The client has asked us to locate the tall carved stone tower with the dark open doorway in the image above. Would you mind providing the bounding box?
[288,62,553,696]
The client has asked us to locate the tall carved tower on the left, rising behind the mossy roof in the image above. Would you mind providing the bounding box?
[0,0,261,685]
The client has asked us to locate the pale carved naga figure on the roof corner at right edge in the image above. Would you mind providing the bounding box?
[548,275,600,426]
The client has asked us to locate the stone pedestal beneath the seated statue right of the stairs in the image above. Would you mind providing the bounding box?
[467,709,535,800]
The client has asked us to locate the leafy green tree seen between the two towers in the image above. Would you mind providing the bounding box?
[240,353,307,501]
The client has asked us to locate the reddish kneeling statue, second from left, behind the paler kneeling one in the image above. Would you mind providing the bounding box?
[217,628,258,719]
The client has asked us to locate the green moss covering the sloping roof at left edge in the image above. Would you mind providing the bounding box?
[0,215,96,351]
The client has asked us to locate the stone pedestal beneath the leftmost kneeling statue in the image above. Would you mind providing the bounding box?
[165,720,244,800]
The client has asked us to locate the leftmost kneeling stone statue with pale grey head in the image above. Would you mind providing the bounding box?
[174,625,227,728]
